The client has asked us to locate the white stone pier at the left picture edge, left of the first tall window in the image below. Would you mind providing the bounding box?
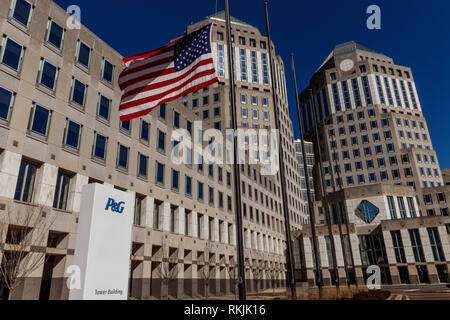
[0,150,22,199]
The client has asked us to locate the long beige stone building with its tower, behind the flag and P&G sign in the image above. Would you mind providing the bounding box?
[0,0,306,299]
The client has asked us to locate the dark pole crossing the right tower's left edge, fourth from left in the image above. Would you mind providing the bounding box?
[308,89,339,290]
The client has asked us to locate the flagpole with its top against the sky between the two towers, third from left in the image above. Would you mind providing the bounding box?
[291,54,322,297]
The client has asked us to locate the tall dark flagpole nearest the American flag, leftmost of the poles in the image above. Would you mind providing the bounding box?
[225,0,246,300]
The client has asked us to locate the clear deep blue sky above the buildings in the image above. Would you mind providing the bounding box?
[56,0,450,168]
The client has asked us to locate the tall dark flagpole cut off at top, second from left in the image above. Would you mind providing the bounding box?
[264,2,297,299]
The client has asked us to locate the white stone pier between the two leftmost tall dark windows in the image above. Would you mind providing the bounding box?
[34,163,58,207]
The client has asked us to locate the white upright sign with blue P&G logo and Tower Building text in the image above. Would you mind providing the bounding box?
[69,184,134,300]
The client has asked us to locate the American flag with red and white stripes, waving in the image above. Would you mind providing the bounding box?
[119,24,218,121]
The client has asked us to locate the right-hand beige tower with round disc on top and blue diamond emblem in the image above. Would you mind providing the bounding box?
[297,42,450,284]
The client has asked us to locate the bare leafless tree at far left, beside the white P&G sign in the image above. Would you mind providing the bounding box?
[0,205,56,299]
